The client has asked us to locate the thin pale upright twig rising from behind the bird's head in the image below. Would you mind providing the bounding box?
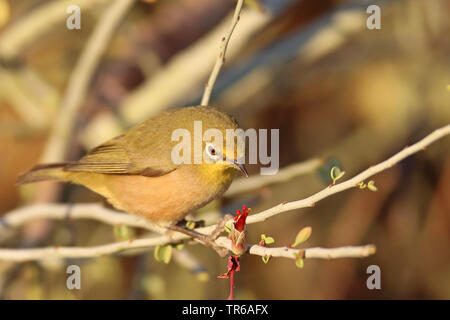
[201,0,244,106]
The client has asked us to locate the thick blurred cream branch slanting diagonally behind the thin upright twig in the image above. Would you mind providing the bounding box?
[117,2,275,125]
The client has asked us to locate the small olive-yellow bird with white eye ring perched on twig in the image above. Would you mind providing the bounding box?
[18,106,248,244]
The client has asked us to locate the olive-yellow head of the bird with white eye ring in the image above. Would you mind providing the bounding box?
[164,106,248,182]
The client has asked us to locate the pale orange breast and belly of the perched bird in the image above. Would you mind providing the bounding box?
[71,166,236,225]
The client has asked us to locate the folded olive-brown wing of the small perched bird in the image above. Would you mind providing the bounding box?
[64,135,177,177]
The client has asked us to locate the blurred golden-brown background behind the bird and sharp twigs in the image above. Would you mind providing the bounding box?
[0,0,450,299]
